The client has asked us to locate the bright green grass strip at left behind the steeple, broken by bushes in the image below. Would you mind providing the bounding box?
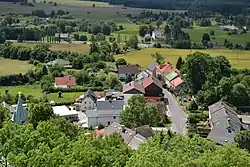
[0,85,84,103]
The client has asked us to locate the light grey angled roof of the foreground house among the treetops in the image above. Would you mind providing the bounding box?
[104,122,147,149]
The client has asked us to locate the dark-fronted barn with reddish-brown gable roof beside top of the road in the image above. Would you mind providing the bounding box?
[143,76,162,96]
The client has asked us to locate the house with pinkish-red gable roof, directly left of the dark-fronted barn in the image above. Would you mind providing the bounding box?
[123,81,145,94]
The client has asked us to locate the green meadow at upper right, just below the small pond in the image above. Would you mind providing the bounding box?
[184,26,250,45]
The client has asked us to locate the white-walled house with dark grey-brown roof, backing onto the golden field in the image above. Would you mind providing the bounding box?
[118,65,139,80]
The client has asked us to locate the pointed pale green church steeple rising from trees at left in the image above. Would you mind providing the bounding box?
[12,92,28,125]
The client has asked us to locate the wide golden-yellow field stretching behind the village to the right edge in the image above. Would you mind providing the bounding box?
[115,48,250,68]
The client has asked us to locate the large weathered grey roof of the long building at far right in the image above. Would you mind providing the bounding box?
[208,101,248,144]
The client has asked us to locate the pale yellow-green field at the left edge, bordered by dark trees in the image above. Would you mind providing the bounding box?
[0,58,33,76]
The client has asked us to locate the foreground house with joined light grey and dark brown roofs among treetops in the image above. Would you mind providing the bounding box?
[100,122,153,150]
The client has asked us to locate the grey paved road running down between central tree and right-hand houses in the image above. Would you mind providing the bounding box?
[163,89,187,135]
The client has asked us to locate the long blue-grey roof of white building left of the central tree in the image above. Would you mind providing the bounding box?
[96,100,124,110]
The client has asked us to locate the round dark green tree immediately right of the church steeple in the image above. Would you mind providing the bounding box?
[29,102,54,127]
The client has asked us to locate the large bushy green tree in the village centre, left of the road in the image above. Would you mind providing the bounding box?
[120,95,170,128]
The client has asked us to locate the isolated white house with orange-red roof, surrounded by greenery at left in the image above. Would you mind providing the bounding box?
[54,76,76,88]
